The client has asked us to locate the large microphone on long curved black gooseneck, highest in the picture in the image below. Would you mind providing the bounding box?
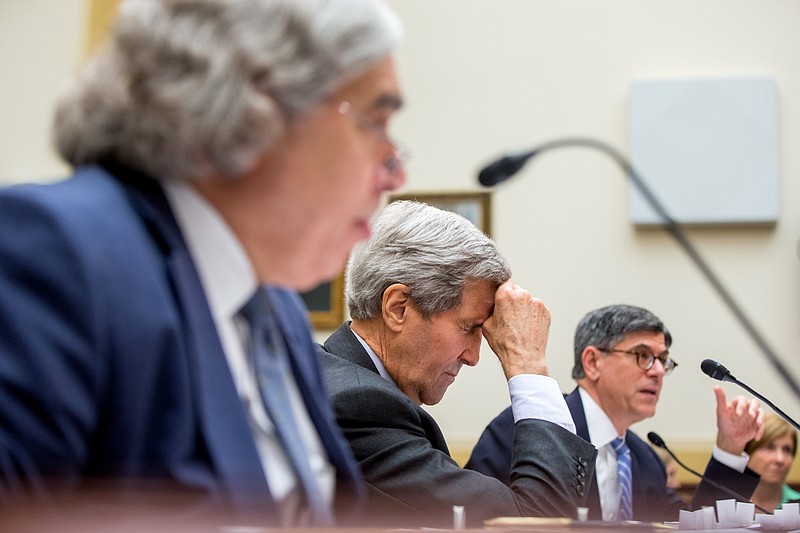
[478,137,800,400]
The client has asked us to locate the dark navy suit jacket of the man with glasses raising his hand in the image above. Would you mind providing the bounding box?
[466,389,759,522]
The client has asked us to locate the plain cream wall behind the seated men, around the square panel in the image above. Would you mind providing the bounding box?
[0,0,800,482]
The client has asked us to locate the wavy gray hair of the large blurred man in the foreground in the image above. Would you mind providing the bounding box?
[54,0,401,178]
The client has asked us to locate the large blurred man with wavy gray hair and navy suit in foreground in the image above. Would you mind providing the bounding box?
[0,0,405,525]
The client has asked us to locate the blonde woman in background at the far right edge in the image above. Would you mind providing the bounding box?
[744,413,800,511]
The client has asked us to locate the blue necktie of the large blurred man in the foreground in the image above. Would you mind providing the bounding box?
[242,288,333,526]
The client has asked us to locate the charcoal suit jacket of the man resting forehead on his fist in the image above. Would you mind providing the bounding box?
[320,323,597,527]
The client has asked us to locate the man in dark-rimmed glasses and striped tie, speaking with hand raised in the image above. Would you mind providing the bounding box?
[466,305,764,522]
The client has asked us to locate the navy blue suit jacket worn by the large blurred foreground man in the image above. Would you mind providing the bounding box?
[0,167,364,521]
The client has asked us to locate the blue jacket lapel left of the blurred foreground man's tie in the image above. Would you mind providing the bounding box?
[115,169,272,512]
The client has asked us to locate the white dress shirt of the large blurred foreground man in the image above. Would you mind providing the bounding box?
[164,181,336,522]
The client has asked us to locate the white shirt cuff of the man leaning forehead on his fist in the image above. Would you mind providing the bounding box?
[508,374,575,433]
